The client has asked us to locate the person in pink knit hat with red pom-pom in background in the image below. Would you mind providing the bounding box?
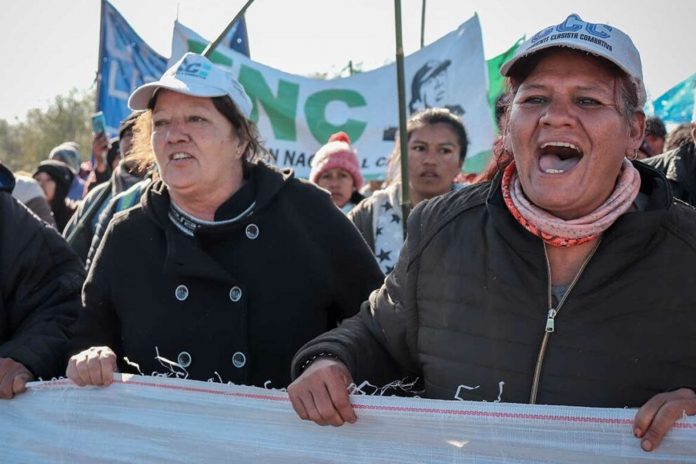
[309,132,365,214]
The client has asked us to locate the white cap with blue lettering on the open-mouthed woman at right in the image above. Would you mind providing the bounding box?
[500,13,646,107]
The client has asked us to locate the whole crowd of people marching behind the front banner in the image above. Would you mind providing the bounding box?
[0,15,696,451]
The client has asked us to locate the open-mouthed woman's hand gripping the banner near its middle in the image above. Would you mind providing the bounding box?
[288,359,357,426]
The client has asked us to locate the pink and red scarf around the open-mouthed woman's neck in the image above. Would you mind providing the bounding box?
[501,159,640,247]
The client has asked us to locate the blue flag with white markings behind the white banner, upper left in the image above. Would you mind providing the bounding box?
[97,0,249,135]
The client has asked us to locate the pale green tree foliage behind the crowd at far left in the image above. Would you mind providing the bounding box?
[0,89,95,173]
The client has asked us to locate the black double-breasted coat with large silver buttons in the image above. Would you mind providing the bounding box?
[74,164,383,388]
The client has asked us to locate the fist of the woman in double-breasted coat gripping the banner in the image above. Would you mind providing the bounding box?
[65,346,116,387]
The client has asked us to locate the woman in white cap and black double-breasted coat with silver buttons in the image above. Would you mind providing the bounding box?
[67,53,383,388]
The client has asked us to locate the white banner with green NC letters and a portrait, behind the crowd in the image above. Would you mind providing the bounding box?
[170,16,493,178]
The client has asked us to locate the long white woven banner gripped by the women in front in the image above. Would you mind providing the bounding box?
[0,375,696,464]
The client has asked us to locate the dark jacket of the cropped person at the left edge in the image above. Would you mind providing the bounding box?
[0,165,84,379]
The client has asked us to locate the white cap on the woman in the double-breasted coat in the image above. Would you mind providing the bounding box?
[128,52,253,119]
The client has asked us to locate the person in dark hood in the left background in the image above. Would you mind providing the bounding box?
[34,159,75,232]
